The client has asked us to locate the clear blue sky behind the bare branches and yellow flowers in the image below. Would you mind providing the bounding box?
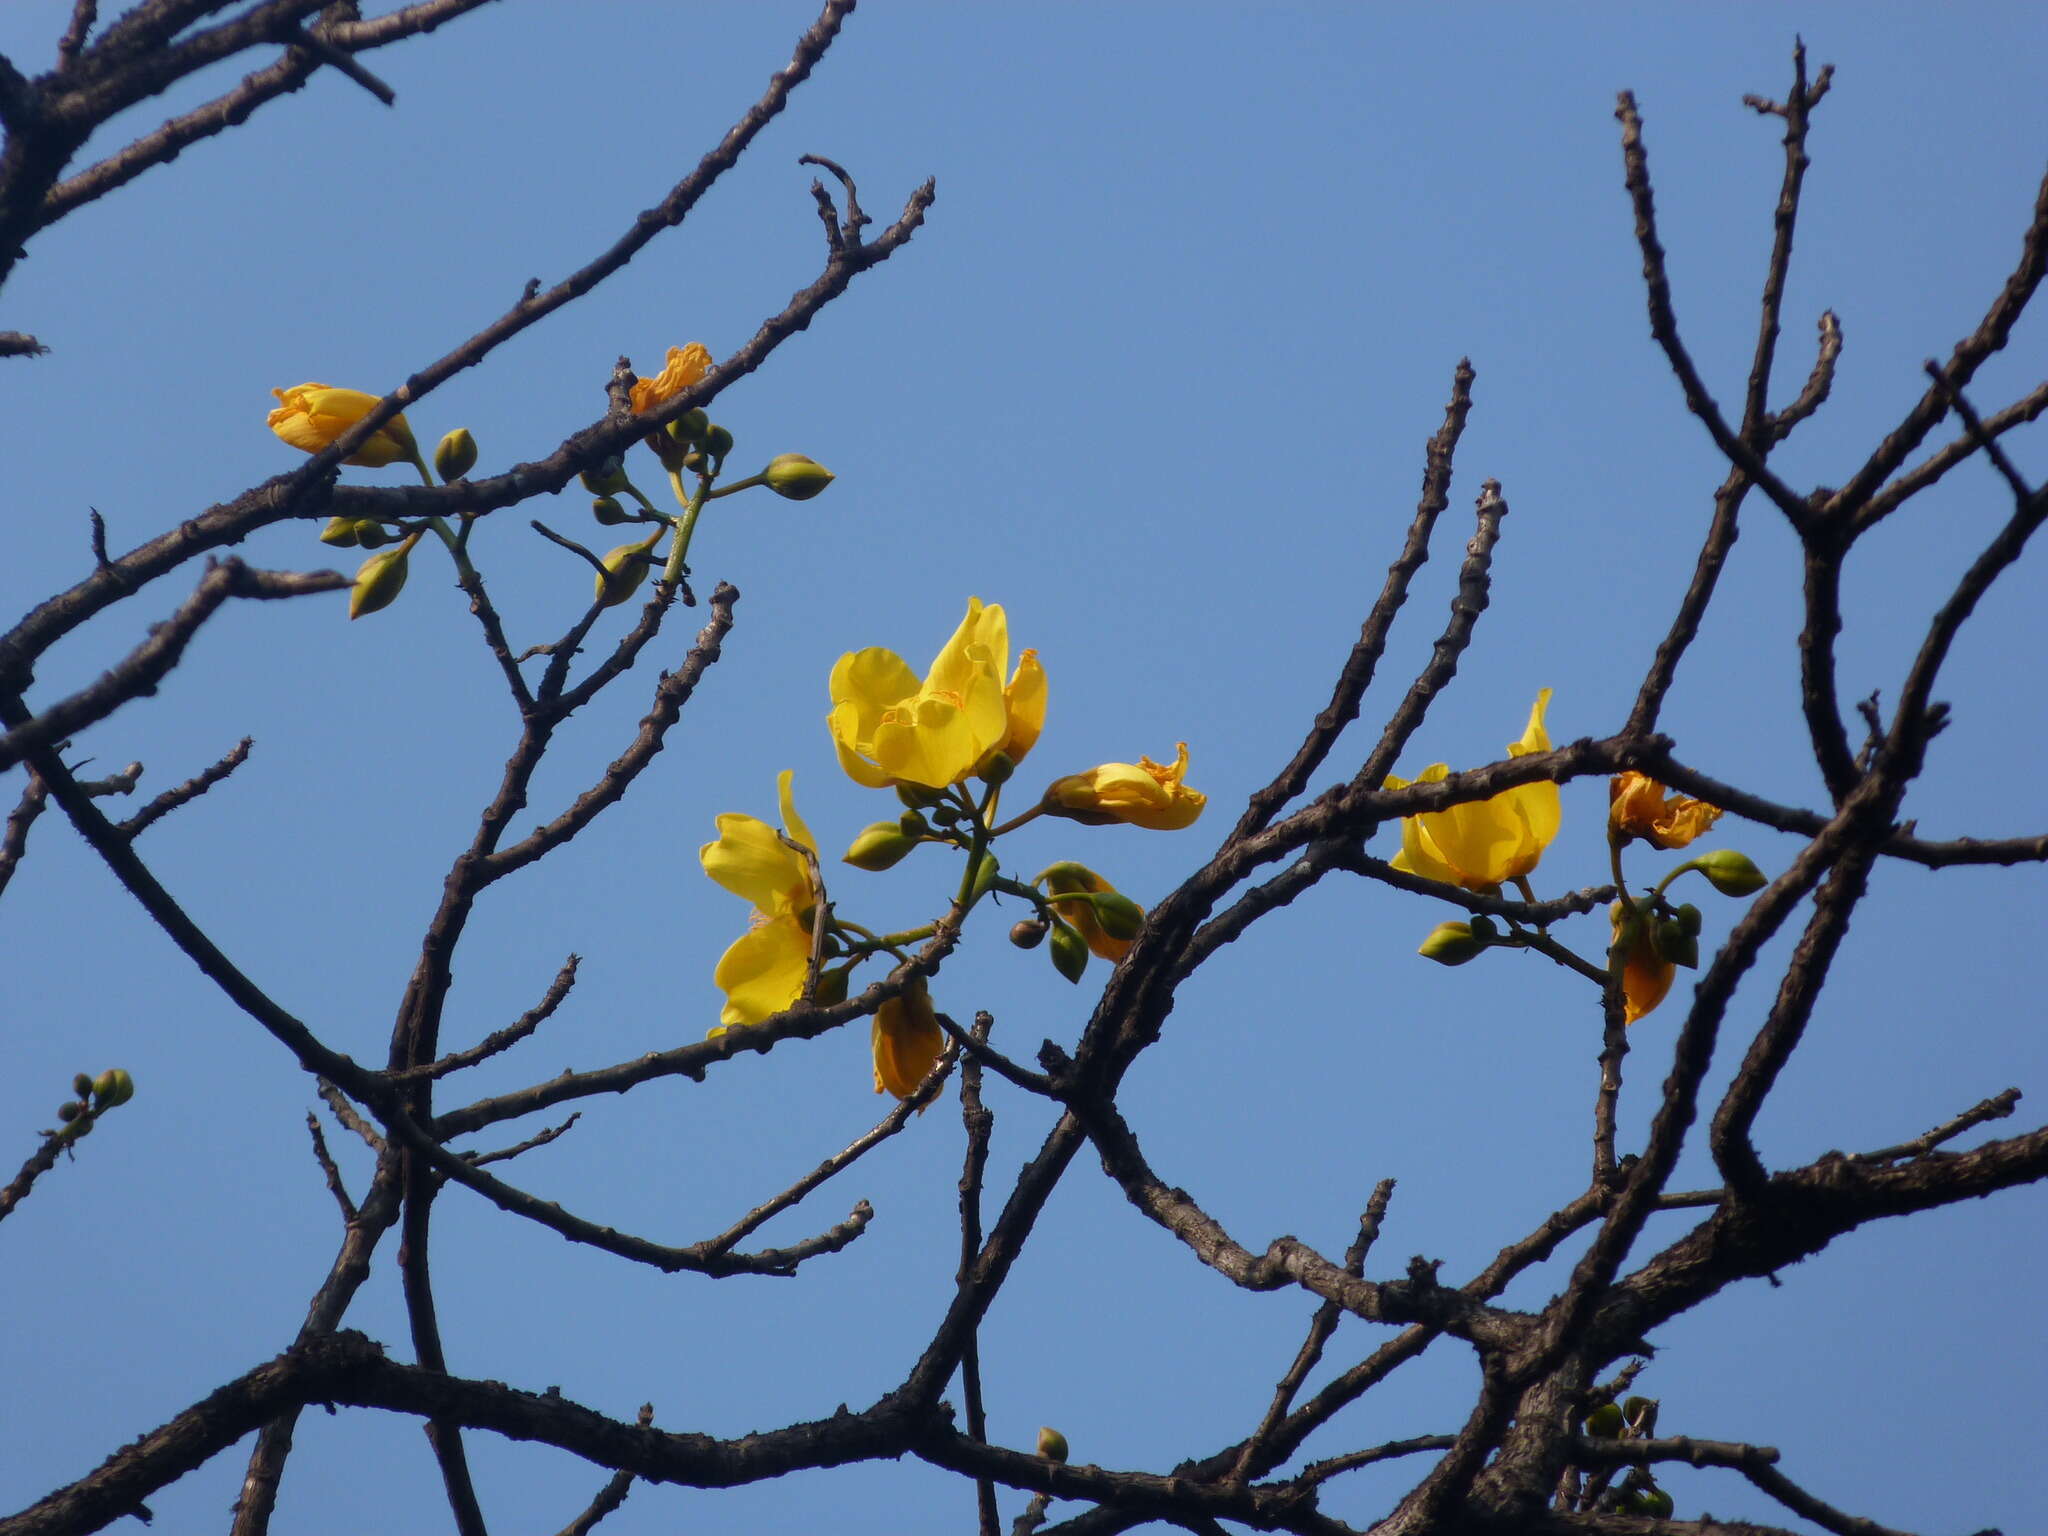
[0,0,2048,1532]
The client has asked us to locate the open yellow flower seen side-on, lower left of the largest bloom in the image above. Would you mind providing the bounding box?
[696,768,817,1034]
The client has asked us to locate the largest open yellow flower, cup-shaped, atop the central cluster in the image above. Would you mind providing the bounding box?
[825,598,1044,788]
